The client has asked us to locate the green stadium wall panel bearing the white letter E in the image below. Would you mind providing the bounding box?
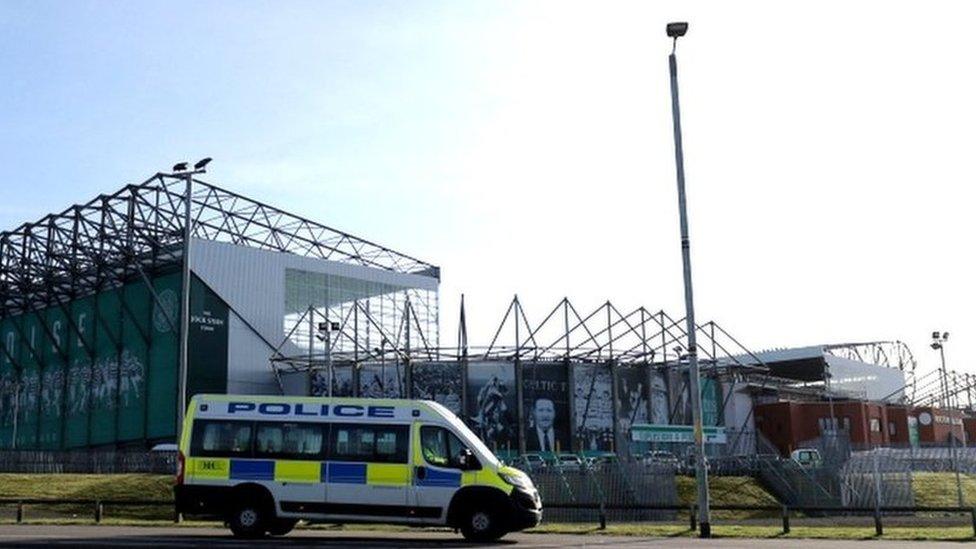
[64,297,97,448]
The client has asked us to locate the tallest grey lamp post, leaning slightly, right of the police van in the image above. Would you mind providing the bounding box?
[667,23,712,538]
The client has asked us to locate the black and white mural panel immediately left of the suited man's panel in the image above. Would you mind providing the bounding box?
[467,362,518,457]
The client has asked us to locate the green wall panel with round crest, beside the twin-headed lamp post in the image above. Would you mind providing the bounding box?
[146,273,180,439]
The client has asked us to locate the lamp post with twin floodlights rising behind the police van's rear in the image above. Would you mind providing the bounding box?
[173,157,212,444]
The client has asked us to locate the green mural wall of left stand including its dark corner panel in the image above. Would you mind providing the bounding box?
[0,275,228,449]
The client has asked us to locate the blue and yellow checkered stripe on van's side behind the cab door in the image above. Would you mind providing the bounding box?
[187,458,418,486]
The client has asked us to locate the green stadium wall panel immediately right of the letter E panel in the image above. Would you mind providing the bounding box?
[90,289,122,445]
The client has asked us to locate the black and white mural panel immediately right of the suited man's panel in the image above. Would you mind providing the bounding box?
[573,364,614,452]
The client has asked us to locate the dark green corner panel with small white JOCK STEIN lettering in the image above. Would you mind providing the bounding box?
[187,277,230,401]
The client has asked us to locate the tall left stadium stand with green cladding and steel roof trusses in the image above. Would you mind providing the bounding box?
[0,174,439,450]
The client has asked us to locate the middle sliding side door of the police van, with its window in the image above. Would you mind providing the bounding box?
[323,423,410,522]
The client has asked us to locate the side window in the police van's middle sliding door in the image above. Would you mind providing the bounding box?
[329,423,409,463]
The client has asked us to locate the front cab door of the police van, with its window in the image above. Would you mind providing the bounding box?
[412,423,473,524]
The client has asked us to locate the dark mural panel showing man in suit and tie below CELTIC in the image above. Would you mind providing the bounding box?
[522,362,572,454]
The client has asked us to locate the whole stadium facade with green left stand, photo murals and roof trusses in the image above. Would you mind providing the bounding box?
[0,168,928,456]
